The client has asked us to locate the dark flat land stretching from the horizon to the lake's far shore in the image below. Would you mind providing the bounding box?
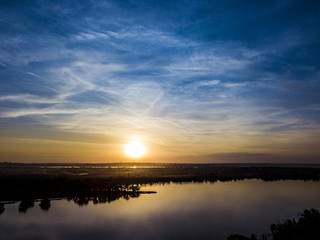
[0,163,320,201]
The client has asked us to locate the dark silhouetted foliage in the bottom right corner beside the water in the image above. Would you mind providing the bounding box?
[227,209,320,240]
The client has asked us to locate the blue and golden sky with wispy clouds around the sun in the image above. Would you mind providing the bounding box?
[0,0,320,163]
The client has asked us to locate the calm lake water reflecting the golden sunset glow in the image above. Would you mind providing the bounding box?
[0,180,320,240]
